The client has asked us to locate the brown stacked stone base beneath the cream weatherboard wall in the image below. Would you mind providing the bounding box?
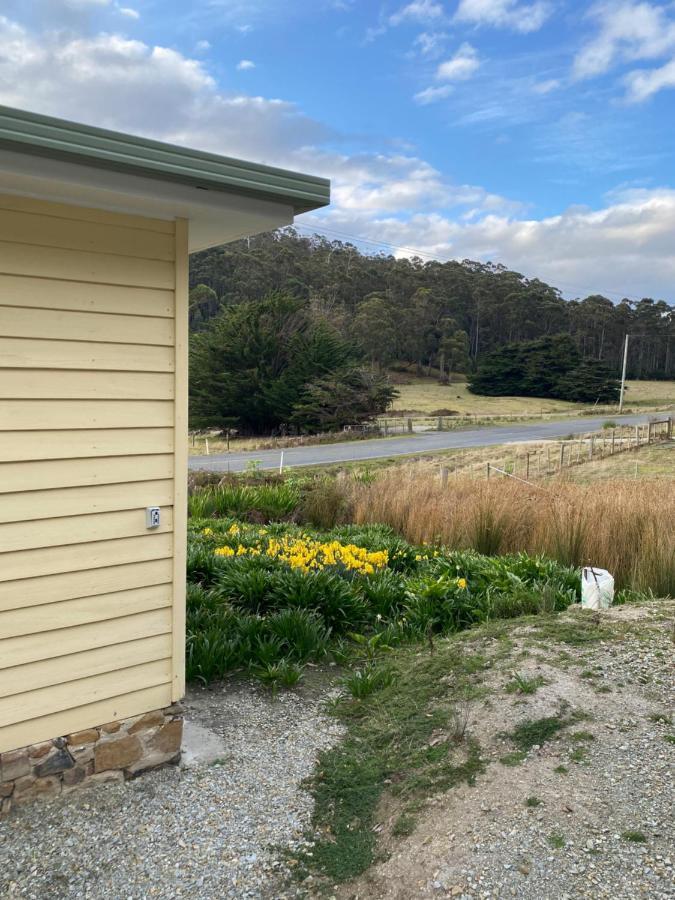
[0,703,183,815]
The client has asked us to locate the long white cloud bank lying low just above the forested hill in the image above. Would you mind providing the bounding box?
[308,188,675,299]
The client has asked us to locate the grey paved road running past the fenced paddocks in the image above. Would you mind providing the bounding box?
[189,415,672,472]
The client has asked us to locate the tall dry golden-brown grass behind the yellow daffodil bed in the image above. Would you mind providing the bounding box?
[353,470,675,596]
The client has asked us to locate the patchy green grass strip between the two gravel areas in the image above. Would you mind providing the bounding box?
[300,639,485,882]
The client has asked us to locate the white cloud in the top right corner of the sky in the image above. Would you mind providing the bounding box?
[574,0,675,78]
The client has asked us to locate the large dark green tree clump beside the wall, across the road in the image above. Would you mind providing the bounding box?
[190,291,396,434]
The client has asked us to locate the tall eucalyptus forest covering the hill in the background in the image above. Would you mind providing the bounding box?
[190,228,675,378]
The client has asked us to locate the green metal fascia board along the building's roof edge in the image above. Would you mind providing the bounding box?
[0,106,330,214]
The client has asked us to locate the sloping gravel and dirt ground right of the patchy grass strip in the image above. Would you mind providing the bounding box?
[348,603,675,900]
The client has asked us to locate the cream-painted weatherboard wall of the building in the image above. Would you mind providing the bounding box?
[0,195,188,752]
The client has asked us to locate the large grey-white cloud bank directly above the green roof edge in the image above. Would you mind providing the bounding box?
[0,17,329,162]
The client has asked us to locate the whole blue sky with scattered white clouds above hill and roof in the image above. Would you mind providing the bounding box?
[0,0,675,301]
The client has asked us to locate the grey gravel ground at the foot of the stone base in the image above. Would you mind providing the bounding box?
[0,685,340,900]
